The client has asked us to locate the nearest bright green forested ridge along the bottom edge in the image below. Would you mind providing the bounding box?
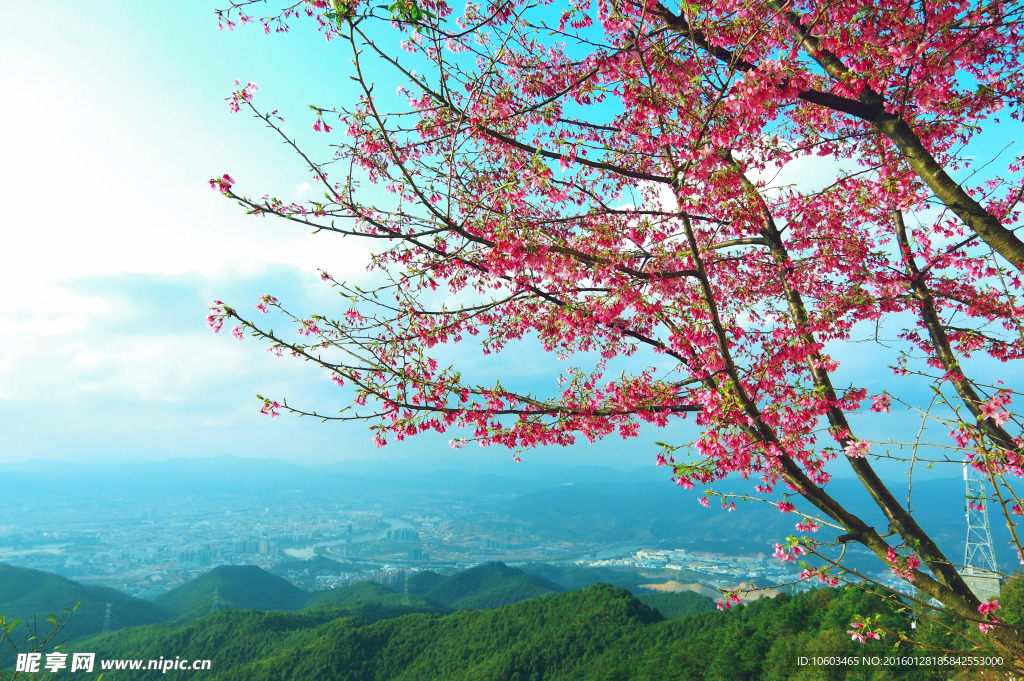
[64,585,940,681]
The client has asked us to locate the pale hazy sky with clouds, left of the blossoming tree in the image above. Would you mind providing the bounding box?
[0,0,1019,477]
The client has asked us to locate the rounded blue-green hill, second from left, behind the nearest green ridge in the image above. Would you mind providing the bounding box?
[154,565,309,624]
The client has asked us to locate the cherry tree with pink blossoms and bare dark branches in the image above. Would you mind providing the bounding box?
[209,0,1024,666]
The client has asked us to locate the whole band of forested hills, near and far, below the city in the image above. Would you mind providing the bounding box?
[6,563,1024,681]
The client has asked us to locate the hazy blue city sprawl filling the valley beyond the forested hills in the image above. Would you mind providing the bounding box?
[0,496,831,597]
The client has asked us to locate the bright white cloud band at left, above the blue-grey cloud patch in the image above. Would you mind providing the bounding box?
[0,81,376,286]
